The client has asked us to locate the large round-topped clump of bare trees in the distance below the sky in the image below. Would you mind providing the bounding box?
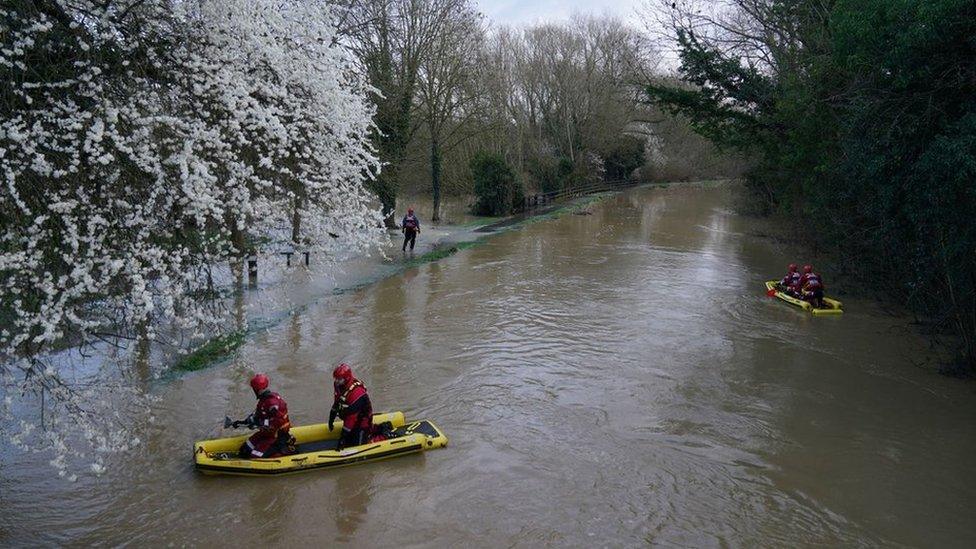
[468,17,656,187]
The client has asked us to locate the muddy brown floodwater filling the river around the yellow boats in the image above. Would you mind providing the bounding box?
[0,183,976,547]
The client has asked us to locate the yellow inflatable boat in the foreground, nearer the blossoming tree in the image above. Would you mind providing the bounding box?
[193,412,447,476]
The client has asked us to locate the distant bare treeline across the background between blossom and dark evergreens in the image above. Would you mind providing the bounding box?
[332,0,741,223]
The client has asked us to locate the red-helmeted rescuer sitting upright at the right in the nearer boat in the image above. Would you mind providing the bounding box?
[329,363,386,450]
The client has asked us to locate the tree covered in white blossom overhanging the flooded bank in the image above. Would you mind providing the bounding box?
[0,0,382,472]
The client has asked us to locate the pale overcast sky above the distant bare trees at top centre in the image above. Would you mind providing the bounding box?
[477,0,644,25]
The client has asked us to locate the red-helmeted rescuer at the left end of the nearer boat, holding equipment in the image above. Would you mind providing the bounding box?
[240,374,295,458]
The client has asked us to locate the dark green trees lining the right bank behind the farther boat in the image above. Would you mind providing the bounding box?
[647,0,976,367]
